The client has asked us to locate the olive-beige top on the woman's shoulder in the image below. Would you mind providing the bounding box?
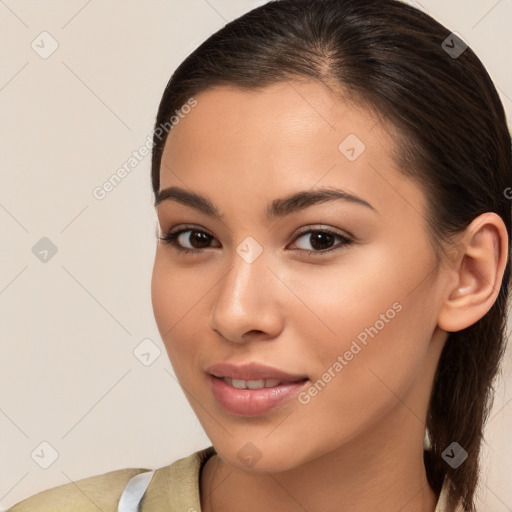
[7,446,454,512]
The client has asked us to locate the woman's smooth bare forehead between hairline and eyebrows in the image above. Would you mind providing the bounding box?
[160,81,424,222]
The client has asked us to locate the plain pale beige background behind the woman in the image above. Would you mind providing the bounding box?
[0,0,512,512]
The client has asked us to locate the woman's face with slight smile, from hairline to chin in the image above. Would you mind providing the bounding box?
[152,82,441,471]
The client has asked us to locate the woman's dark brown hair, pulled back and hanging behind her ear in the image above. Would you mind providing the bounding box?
[152,0,512,512]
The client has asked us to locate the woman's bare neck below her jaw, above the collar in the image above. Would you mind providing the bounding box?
[200,412,437,512]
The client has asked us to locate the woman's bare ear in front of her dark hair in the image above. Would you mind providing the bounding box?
[438,212,510,332]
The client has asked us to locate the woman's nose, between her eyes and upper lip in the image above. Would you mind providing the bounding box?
[210,252,283,343]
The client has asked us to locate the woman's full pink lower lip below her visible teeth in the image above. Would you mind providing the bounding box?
[209,375,309,417]
